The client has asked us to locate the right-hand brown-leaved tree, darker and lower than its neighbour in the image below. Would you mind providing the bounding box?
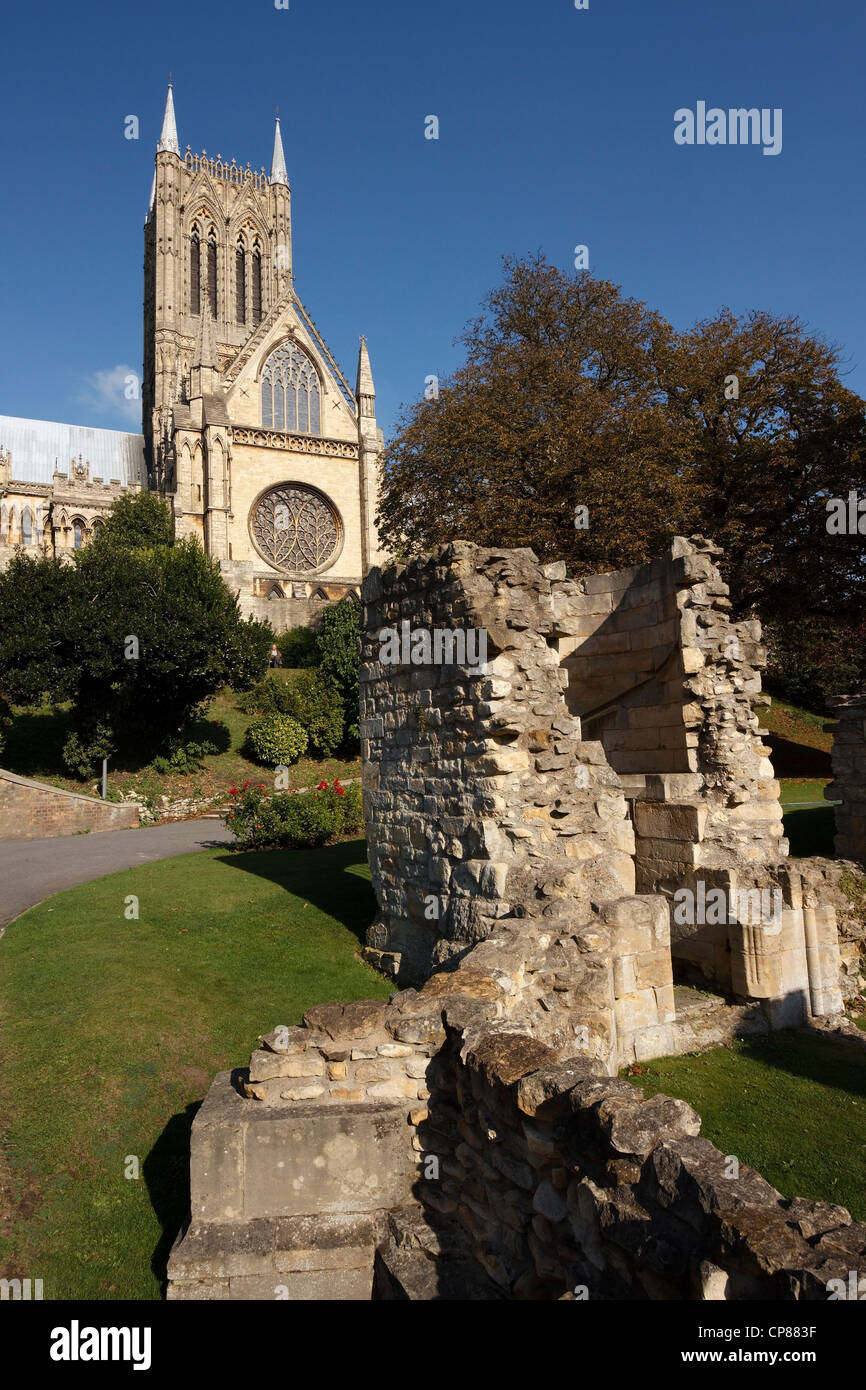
[659,310,866,619]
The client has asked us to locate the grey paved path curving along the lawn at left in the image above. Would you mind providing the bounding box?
[0,817,234,934]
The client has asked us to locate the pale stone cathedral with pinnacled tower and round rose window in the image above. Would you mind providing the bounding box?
[0,86,384,630]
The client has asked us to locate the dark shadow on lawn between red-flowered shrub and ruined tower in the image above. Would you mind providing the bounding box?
[218,840,375,945]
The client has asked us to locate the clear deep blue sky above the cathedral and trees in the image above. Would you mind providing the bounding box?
[0,0,866,443]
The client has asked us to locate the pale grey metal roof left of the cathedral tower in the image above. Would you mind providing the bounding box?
[0,416,147,487]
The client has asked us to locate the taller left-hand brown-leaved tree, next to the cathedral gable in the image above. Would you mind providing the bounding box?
[379,256,695,573]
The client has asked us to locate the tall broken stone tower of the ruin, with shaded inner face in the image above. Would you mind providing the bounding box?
[361,537,841,1034]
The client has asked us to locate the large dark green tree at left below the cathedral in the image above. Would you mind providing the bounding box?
[0,539,274,771]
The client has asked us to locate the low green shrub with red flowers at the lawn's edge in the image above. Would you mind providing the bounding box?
[225,780,364,849]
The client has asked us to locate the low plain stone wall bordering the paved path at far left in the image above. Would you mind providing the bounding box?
[0,769,139,840]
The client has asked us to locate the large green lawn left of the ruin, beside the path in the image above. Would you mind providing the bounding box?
[0,840,393,1298]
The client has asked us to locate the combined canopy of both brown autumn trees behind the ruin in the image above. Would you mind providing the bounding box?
[379,256,866,700]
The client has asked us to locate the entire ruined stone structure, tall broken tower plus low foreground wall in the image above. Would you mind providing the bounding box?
[168,542,866,1300]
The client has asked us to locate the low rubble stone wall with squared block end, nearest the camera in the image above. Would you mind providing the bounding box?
[168,967,866,1300]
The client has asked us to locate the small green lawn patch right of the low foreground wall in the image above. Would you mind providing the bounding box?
[630,1031,866,1220]
